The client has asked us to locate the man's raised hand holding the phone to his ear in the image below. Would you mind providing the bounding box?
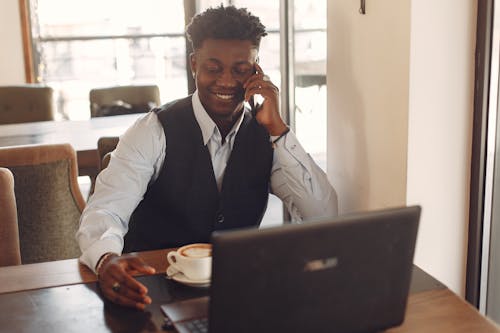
[243,63,287,135]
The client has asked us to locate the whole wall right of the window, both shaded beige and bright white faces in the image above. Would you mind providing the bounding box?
[327,0,476,296]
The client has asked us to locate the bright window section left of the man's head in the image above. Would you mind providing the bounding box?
[30,0,187,119]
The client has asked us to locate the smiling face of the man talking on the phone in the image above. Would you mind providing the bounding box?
[191,39,257,119]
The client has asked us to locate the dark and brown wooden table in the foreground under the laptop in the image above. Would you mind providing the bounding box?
[0,250,500,333]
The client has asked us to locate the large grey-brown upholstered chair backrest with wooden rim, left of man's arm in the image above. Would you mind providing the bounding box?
[0,144,85,264]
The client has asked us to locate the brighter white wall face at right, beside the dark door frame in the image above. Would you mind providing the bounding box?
[407,0,477,295]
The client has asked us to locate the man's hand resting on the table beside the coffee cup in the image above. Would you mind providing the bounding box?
[97,254,156,310]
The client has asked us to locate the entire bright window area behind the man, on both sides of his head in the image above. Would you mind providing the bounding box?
[23,0,326,224]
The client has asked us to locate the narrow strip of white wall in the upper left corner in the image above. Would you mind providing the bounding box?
[0,0,25,85]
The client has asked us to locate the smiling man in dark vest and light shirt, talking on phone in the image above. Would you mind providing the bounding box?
[77,6,337,309]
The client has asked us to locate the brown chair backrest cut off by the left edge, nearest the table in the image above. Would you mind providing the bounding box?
[0,168,21,266]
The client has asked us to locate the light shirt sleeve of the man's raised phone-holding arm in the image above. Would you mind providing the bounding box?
[271,131,338,222]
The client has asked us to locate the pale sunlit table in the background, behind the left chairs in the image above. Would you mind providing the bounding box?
[0,113,144,176]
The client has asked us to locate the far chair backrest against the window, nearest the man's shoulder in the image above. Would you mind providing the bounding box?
[89,85,160,117]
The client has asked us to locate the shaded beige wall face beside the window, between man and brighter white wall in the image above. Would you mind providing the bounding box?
[327,0,410,213]
